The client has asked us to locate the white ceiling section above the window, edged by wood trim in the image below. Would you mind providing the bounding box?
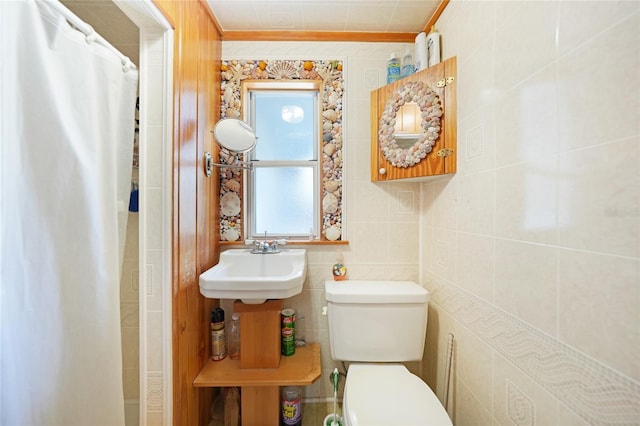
[207,0,441,33]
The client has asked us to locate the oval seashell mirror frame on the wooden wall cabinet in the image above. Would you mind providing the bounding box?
[378,81,443,168]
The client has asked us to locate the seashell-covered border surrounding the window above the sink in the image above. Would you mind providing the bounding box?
[219,59,344,241]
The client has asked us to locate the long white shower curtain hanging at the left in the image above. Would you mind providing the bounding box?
[0,0,138,426]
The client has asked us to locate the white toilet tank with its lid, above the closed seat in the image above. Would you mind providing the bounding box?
[325,280,429,362]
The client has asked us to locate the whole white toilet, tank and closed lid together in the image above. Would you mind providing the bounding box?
[325,280,452,426]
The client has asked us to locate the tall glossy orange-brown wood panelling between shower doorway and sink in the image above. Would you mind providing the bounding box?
[155,0,221,426]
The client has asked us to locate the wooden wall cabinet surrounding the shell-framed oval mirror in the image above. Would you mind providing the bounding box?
[371,57,457,182]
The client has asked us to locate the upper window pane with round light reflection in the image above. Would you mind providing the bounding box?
[251,91,317,161]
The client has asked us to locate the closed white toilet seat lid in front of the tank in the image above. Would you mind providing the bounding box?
[343,364,452,426]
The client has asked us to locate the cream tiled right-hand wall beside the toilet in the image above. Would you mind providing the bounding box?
[420,0,640,425]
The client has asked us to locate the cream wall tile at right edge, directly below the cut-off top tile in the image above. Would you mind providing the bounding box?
[558,13,640,151]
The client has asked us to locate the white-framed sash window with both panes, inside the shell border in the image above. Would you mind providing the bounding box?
[242,80,322,239]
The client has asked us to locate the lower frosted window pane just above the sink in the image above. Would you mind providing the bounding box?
[252,167,315,237]
